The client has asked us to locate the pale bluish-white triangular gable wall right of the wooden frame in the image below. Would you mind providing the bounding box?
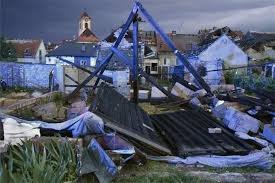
[199,35,248,66]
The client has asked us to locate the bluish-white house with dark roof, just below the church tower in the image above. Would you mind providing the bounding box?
[46,42,99,67]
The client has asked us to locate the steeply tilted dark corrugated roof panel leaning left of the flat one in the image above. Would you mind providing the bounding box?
[95,83,170,154]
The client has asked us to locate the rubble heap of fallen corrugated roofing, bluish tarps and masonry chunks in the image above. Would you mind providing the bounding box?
[0,82,274,182]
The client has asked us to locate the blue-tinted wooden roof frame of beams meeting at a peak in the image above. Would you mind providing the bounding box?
[62,2,213,102]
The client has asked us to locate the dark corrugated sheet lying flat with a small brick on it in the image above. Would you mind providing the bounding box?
[151,110,252,157]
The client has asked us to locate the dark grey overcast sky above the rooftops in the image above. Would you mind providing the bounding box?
[0,0,275,41]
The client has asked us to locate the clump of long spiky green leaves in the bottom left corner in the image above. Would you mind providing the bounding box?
[0,140,76,183]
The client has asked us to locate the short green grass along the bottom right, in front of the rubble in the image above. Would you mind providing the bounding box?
[114,161,275,183]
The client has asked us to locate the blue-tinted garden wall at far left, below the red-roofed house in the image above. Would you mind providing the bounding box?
[0,61,56,88]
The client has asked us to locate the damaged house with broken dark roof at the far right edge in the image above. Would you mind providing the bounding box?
[240,31,275,60]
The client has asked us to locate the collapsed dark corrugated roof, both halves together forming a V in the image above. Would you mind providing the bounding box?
[95,83,253,157]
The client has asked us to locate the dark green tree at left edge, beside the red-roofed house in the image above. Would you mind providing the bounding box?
[0,37,16,61]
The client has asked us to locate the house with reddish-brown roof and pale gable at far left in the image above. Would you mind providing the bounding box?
[6,39,47,63]
